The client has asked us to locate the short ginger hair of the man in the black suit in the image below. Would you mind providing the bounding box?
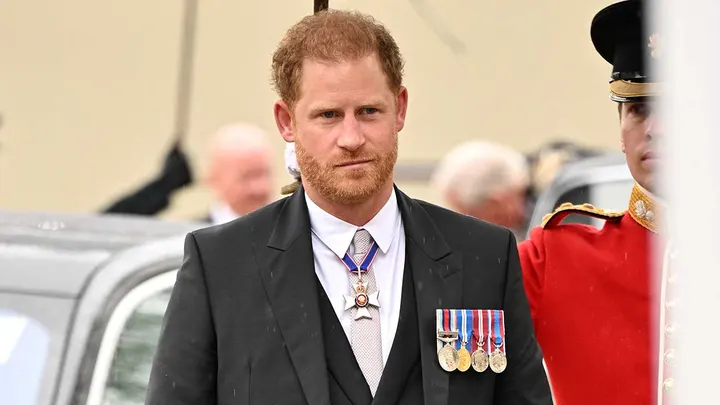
[272,10,404,108]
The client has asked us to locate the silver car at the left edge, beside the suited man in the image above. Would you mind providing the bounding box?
[0,213,201,405]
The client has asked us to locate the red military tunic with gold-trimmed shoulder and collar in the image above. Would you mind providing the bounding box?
[519,186,672,405]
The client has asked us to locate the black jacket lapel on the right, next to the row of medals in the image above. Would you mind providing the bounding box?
[395,188,462,405]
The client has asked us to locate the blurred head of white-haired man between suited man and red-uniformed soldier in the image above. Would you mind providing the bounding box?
[431,141,529,240]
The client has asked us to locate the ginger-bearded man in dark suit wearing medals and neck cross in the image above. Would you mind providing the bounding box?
[146,7,552,405]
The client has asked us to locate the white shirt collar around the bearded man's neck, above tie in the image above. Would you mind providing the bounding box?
[305,189,401,258]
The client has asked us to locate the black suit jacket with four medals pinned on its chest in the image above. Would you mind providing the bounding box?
[146,188,552,405]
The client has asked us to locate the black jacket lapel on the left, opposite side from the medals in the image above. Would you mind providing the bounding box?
[255,189,330,405]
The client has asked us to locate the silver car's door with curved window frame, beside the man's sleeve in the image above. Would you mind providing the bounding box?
[54,236,184,405]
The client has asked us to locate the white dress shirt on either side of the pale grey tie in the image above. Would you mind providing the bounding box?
[305,190,405,365]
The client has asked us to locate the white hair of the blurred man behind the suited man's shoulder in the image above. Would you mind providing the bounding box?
[432,141,529,207]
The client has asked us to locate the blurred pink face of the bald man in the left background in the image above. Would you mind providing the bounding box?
[213,149,272,215]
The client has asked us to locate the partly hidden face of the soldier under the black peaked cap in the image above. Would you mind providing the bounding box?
[620,102,660,191]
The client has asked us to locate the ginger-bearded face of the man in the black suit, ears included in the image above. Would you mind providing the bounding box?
[275,55,407,204]
